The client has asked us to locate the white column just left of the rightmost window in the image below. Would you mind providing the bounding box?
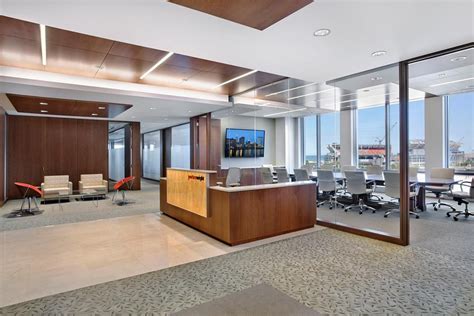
[424,97,446,175]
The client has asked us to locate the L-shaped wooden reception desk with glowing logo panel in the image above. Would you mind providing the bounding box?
[160,169,316,245]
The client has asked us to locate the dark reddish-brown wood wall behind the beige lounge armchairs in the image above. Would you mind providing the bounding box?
[7,116,108,199]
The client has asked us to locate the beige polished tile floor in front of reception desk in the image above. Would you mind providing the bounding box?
[0,213,323,306]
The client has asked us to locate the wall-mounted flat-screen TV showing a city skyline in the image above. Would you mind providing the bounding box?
[224,128,265,158]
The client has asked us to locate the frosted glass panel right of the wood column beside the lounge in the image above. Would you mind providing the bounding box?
[142,131,161,180]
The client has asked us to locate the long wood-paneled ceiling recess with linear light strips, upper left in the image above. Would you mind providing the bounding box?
[0,16,284,95]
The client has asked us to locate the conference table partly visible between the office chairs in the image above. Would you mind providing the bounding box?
[309,171,460,212]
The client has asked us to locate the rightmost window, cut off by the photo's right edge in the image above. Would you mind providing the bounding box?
[446,92,474,171]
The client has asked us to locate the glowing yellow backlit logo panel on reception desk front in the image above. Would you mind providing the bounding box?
[166,168,209,217]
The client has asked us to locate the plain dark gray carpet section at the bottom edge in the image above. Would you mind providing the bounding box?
[173,284,321,316]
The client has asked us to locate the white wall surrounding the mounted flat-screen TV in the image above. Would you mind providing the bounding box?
[221,115,278,169]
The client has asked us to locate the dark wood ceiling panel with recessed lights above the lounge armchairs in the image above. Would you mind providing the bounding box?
[7,94,132,118]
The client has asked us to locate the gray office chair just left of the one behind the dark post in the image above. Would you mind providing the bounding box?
[344,170,375,214]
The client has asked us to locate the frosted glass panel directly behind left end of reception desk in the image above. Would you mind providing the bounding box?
[171,124,191,169]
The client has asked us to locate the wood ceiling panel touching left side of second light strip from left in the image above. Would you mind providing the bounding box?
[96,54,155,82]
